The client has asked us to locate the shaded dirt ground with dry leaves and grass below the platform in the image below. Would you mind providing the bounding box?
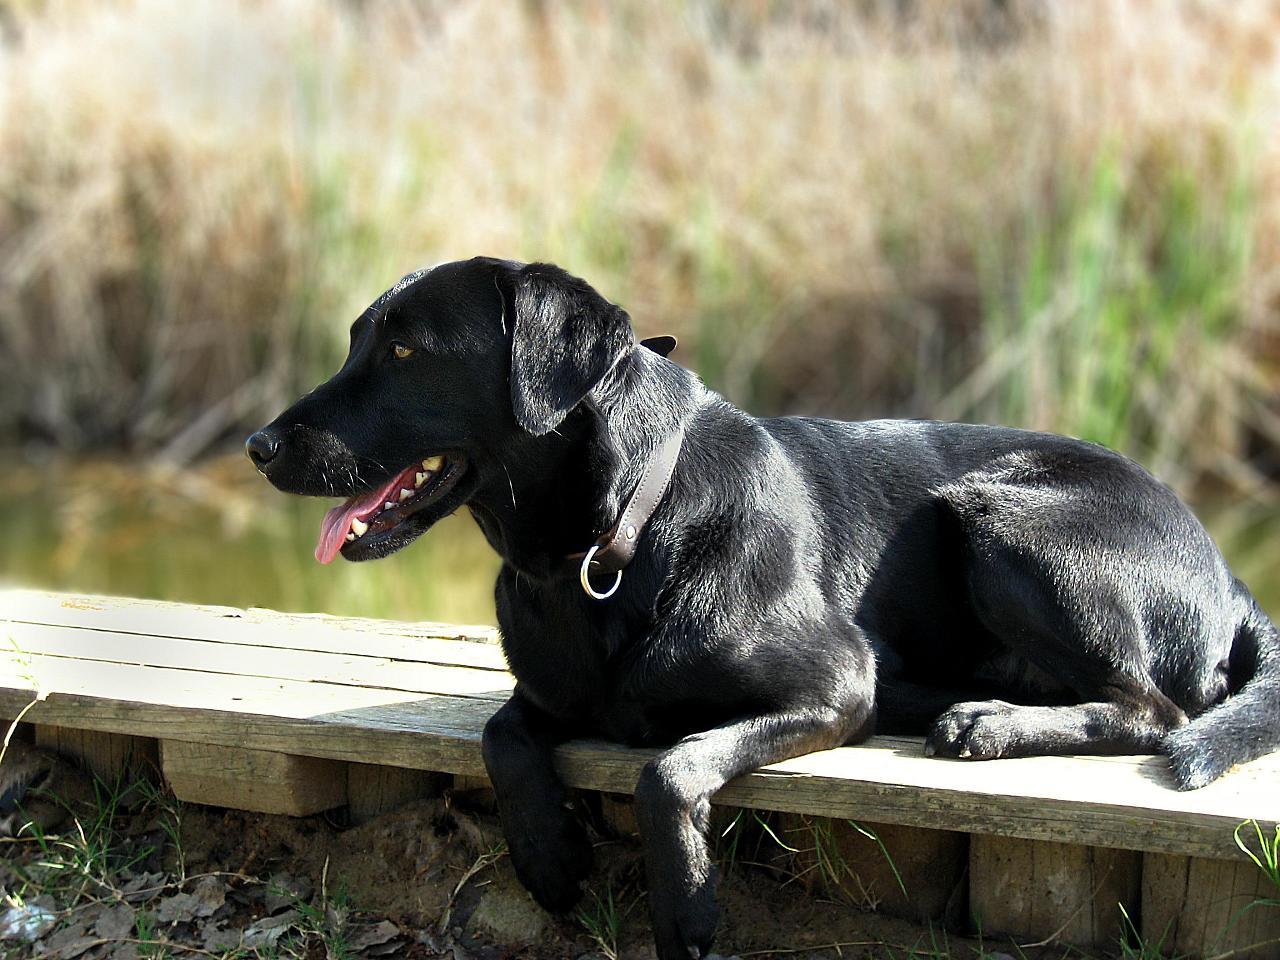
[0,747,1074,960]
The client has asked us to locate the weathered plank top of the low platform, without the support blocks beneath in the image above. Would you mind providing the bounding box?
[0,591,1280,859]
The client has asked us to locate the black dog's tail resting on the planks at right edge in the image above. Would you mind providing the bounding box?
[1165,580,1280,790]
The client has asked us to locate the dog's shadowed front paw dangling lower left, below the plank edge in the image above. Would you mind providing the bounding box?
[507,808,593,914]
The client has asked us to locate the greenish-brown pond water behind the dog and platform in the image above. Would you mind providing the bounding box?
[0,456,1280,623]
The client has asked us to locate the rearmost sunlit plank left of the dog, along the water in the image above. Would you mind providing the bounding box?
[0,590,507,671]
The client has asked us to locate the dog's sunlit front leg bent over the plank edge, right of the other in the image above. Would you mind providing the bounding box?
[636,695,872,960]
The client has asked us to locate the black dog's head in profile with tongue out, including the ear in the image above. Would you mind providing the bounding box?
[246,257,635,563]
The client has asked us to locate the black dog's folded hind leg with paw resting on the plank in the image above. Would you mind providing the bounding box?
[925,471,1187,759]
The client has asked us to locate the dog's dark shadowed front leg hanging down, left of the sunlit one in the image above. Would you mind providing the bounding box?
[483,686,591,913]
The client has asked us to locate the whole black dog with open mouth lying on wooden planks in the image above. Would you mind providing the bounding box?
[248,259,1280,960]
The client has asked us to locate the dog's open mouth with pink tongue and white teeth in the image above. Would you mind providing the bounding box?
[316,456,463,563]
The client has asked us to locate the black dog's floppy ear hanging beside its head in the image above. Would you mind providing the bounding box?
[508,264,635,436]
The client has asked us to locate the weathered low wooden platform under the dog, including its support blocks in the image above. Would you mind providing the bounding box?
[0,590,1280,956]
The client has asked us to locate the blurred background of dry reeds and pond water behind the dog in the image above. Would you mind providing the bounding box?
[0,0,1280,621]
